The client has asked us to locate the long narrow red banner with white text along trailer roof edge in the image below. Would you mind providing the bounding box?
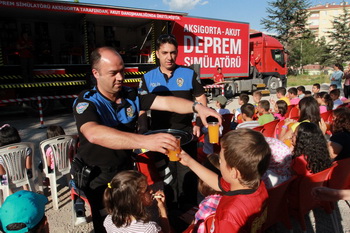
[0,0,182,20]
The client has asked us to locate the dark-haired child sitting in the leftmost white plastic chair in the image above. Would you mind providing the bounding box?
[0,124,33,190]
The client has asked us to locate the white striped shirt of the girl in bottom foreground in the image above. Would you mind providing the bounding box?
[103,215,161,233]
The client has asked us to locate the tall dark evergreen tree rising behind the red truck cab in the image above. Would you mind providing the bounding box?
[261,0,310,46]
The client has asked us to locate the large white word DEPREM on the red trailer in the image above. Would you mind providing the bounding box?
[184,35,242,54]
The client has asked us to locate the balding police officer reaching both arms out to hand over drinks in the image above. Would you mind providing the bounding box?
[73,47,221,232]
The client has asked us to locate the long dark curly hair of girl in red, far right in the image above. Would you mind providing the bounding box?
[293,122,332,173]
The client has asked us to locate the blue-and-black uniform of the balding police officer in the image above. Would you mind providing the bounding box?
[73,87,155,232]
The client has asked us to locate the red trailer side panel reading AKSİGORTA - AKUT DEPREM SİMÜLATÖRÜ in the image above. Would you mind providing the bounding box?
[172,17,249,77]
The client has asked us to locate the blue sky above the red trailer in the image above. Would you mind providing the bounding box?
[80,0,341,32]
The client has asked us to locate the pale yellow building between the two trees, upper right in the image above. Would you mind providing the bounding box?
[308,2,350,43]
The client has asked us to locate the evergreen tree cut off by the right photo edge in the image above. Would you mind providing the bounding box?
[329,6,350,64]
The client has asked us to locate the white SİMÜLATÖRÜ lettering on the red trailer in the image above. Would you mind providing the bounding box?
[184,55,242,68]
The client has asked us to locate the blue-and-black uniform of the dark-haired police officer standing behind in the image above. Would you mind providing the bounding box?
[139,65,205,208]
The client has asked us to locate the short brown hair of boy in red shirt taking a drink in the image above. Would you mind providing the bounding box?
[220,128,271,189]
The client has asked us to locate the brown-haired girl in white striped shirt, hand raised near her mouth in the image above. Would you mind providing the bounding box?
[103,170,170,233]
